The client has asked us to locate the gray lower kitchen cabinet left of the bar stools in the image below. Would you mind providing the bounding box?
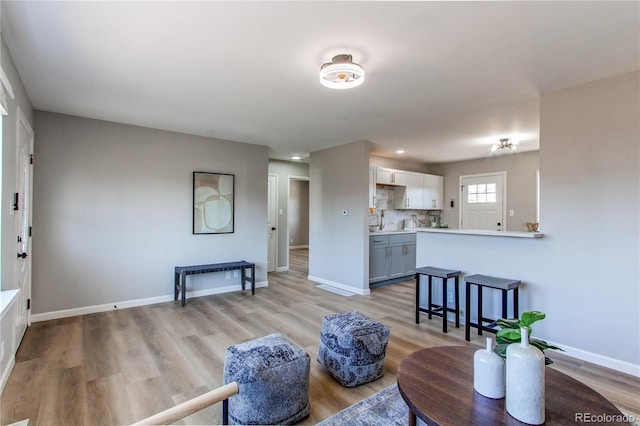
[369,234,416,283]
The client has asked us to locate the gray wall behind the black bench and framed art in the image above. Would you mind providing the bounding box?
[33,111,268,313]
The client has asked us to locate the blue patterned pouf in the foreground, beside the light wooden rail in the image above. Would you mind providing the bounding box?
[224,333,310,425]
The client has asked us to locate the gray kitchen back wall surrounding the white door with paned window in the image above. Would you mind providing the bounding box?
[429,151,544,231]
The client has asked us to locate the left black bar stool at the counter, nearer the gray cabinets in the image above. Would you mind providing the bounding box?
[416,266,461,333]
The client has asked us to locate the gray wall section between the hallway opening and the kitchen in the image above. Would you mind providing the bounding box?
[309,142,370,294]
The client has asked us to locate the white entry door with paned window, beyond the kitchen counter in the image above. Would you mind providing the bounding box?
[460,172,506,231]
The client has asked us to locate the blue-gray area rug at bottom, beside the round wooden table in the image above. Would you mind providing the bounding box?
[316,384,409,426]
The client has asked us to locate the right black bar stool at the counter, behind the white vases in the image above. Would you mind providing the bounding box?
[464,274,521,341]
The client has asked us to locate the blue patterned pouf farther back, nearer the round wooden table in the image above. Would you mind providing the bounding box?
[318,311,389,387]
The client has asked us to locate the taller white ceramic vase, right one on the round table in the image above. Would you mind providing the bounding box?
[505,327,545,425]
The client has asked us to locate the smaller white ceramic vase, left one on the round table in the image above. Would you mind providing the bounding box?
[473,337,504,399]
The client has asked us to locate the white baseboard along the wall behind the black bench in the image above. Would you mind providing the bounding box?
[31,281,269,322]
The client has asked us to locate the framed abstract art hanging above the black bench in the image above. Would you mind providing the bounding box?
[193,172,234,234]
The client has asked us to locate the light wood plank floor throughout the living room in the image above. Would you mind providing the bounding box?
[1,250,640,425]
